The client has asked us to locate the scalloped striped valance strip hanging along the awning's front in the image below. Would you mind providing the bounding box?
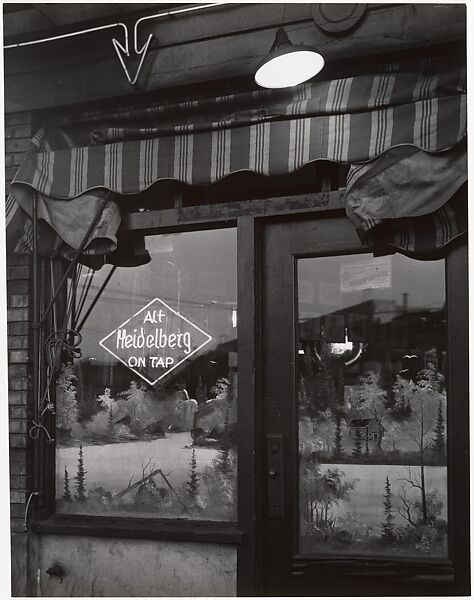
[14,95,465,198]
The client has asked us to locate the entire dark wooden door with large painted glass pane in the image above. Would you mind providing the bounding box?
[262,218,462,596]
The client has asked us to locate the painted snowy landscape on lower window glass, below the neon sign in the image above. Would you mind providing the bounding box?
[56,366,237,520]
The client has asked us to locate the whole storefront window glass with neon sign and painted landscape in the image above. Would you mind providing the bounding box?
[56,229,237,521]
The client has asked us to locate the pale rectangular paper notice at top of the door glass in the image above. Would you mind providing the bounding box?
[341,256,392,292]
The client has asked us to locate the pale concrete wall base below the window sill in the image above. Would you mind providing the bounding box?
[31,535,237,597]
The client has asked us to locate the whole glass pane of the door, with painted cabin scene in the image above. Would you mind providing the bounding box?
[297,254,448,559]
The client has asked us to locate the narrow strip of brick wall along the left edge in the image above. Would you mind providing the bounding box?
[5,113,33,596]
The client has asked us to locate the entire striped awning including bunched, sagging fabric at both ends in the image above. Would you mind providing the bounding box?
[7,58,466,262]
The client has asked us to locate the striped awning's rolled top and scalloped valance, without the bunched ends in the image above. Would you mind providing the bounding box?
[9,58,466,260]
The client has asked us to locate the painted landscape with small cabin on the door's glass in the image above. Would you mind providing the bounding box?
[299,344,447,557]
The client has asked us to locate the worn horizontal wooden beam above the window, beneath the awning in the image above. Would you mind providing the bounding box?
[122,190,345,232]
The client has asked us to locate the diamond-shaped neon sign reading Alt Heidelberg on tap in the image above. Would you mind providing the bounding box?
[99,298,212,385]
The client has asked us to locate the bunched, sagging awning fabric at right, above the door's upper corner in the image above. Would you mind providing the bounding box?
[345,142,467,254]
